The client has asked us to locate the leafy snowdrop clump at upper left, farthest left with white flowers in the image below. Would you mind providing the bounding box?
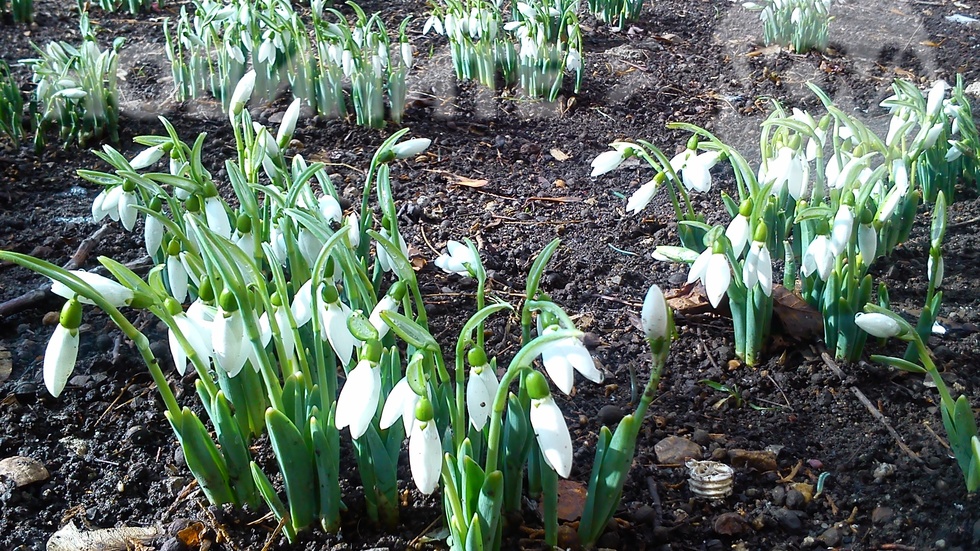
[22,12,123,147]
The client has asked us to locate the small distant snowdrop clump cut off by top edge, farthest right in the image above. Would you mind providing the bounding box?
[743,0,831,53]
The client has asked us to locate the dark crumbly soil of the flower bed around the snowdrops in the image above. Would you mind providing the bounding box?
[0,0,980,550]
